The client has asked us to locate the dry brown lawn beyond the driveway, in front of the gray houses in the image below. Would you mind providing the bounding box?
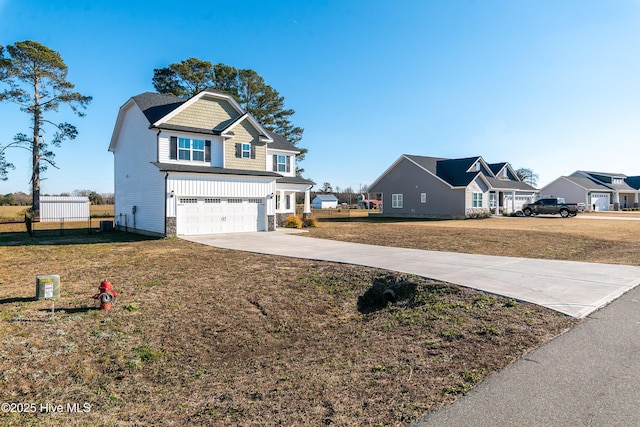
[309,213,640,265]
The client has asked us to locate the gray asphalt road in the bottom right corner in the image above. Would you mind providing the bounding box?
[412,287,640,427]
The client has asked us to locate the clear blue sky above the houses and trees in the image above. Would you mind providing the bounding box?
[0,0,640,194]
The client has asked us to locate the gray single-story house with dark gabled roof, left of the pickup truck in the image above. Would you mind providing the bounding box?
[369,154,538,218]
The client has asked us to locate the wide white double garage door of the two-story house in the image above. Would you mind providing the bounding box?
[176,197,266,235]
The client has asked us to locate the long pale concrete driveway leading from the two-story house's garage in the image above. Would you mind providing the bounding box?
[183,229,640,318]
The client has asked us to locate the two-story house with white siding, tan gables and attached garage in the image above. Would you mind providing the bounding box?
[109,89,313,236]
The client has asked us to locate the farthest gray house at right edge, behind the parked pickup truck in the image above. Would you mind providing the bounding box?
[540,171,640,211]
